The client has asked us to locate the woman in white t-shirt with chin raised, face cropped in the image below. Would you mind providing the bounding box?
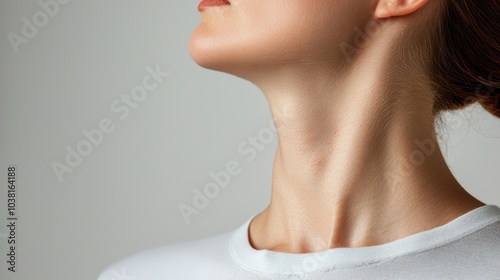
[99,0,500,280]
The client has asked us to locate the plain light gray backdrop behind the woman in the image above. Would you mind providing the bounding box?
[0,0,500,280]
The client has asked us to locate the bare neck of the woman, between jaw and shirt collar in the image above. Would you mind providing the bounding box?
[249,17,485,253]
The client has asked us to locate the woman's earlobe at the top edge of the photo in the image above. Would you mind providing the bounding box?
[375,0,429,18]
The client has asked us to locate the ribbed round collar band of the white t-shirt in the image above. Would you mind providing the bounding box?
[230,204,500,277]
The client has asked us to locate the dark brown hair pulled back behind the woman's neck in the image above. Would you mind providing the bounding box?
[431,0,500,118]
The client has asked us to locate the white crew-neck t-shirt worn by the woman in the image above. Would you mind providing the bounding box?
[98,205,500,280]
